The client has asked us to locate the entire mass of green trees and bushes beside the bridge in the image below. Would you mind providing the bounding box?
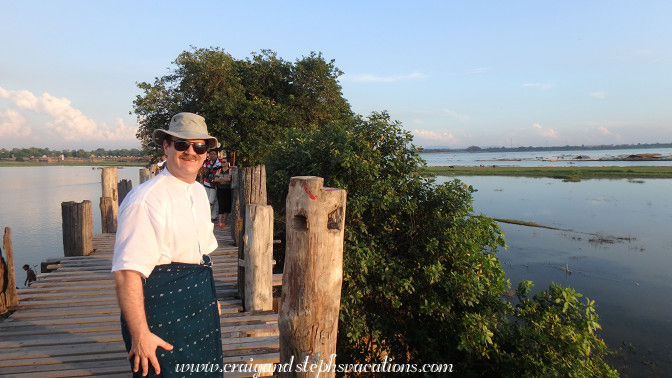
[134,43,616,377]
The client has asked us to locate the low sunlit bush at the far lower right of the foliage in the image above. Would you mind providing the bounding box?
[488,281,618,377]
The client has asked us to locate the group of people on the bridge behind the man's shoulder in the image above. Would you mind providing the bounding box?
[200,149,231,227]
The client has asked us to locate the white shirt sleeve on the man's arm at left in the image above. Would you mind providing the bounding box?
[112,202,165,277]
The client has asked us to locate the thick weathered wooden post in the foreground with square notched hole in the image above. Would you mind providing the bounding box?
[278,176,346,378]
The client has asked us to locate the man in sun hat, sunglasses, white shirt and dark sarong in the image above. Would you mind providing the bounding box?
[112,113,222,377]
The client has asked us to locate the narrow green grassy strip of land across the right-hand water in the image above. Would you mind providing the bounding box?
[425,165,672,181]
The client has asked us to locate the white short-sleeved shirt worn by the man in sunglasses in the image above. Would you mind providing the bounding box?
[112,169,217,277]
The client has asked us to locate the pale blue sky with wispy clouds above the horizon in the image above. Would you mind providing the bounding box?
[0,0,672,150]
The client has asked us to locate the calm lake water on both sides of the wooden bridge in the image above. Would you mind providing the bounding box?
[0,158,672,376]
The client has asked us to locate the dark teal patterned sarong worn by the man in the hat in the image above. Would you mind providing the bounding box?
[121,255,222,377]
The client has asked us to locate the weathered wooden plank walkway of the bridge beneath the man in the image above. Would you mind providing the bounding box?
[0,228,280,378]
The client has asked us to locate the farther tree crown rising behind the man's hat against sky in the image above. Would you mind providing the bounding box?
[134,48,350,166]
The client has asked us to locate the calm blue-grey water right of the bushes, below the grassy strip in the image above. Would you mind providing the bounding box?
[439,177,672,376]
